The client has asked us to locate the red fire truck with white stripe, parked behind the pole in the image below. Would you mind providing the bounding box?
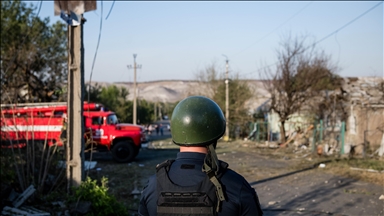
[1,103,147,162]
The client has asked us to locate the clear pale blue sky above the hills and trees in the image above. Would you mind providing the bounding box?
[27,1,384,82]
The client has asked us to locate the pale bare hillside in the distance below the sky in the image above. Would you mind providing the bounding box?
[88,80,269,111]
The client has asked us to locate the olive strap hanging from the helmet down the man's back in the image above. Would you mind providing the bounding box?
[202,142,225,212]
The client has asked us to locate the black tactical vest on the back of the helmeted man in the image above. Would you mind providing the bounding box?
[156,160,228,216]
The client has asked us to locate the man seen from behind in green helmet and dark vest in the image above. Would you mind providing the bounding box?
[139,96,263,216]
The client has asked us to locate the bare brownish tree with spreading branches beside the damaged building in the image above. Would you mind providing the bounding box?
[261,36,337,142]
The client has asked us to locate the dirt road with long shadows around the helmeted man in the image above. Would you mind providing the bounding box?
[89,133,384,216]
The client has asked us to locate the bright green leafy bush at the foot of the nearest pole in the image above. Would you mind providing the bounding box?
[68,177,128,216]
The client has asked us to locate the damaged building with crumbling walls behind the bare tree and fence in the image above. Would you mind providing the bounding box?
[257,77,384,156]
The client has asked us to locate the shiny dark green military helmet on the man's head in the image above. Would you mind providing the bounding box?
[171,96,225,146]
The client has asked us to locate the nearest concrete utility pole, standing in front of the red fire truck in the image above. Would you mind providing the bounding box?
[54,0,96,193]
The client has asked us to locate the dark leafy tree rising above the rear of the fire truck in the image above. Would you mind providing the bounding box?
[0,0,67,103]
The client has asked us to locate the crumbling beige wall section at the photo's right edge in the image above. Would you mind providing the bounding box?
[343,77,384,150]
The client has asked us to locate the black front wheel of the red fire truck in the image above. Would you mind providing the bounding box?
[112,141,135,163]
